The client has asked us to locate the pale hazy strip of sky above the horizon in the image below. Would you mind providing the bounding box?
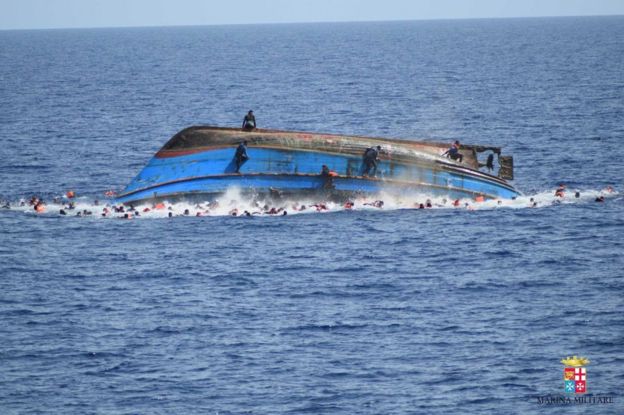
[0,0,624,30]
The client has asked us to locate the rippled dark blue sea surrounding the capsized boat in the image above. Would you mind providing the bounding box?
[0,17,624,415]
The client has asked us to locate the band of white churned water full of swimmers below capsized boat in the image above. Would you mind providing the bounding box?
[2,188,619,219]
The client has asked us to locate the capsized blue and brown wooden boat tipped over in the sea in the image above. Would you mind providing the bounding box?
[116,126,519,204]
